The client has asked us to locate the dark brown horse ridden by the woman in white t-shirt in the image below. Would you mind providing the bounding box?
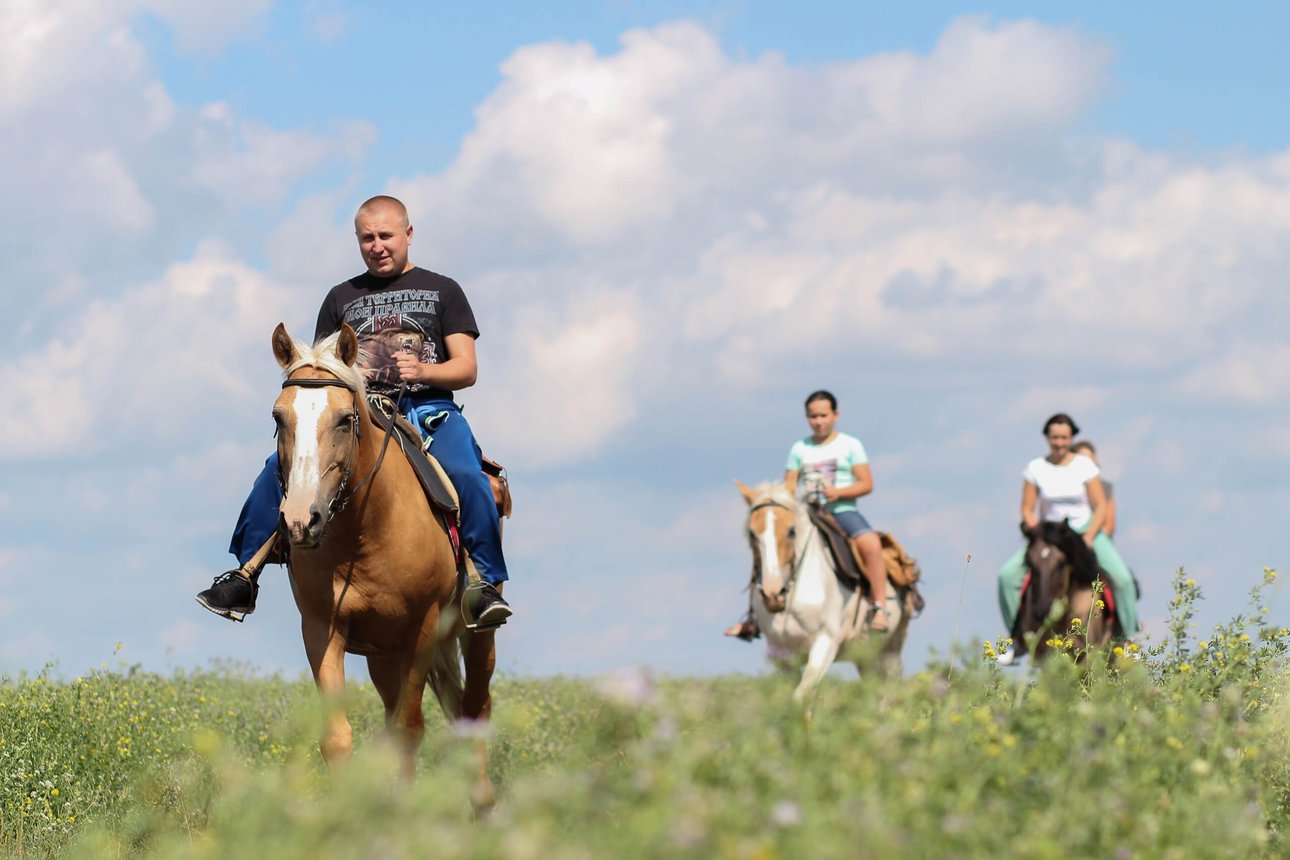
[1013,520,1116,660]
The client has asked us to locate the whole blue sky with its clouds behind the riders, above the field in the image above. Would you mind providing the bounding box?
[0,0,1290,674]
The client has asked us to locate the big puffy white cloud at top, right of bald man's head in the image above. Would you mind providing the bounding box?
[399,19,1108,255]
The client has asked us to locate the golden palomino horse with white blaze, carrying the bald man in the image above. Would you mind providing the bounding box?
[273,324,495,807]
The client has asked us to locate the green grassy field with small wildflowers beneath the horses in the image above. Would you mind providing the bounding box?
[0,571,1290,860]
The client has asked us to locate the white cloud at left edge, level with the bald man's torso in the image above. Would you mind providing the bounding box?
[0,242,301,460]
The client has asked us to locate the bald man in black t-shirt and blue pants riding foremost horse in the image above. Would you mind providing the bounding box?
[197,196,511,628]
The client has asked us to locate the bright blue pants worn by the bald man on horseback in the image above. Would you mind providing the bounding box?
[228,397,508,584]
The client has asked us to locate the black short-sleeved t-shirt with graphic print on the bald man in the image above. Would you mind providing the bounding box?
[313,267,480,400]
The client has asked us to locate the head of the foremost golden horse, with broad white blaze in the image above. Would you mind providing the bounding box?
[273,322,364,547]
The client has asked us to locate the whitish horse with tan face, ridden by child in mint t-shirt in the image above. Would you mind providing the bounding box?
[735,481,909,701]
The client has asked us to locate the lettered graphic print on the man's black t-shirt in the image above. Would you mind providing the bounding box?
[343,290,439,384]
